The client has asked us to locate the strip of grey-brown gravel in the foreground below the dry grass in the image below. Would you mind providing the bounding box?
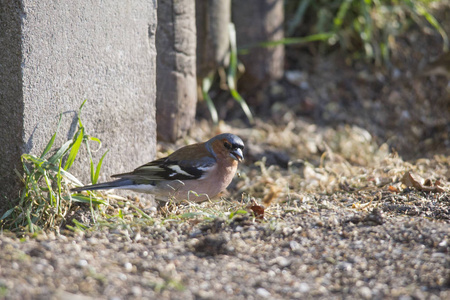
[0,196,450,299]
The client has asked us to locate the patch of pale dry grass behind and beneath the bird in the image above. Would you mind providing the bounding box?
[139,119,450,227]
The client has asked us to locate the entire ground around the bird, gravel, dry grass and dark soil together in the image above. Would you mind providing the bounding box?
[0,5,450,300]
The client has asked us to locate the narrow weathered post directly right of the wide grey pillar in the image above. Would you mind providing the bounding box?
[156,0,197,142]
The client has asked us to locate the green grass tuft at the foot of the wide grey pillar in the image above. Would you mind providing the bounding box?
[0,101,107,233]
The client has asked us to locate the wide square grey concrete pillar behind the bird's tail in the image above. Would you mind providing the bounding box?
[0,0,156,211]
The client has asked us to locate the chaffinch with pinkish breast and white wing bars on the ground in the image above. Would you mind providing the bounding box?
[71,133,244,202]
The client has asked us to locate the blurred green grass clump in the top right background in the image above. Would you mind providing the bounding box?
[278,0,449,65]
